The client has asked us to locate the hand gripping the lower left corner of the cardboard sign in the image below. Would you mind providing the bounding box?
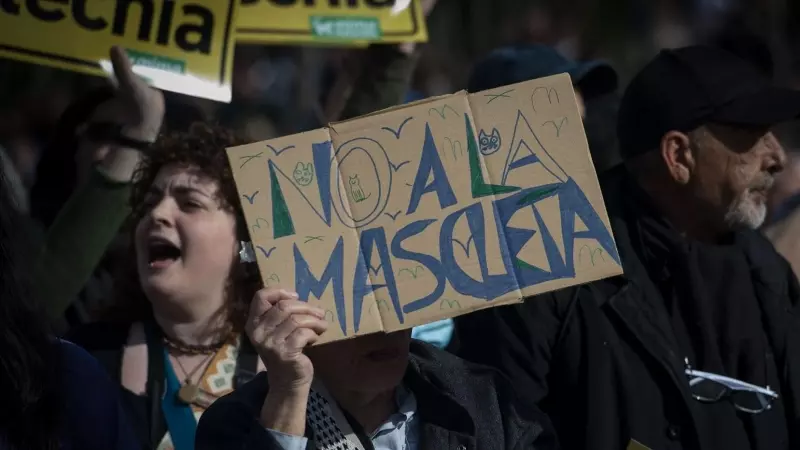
[245,289,328,393]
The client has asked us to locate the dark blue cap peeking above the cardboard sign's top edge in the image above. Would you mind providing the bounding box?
[467,44,617,99]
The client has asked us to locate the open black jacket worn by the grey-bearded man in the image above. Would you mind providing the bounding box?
[454,169,800,450]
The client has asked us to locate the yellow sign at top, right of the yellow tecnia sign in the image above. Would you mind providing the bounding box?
[236,0,428,45]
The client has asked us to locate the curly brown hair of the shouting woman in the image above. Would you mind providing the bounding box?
[110,122,261,331]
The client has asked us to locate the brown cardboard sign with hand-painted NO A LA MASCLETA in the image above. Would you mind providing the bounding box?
[228,74,622,342]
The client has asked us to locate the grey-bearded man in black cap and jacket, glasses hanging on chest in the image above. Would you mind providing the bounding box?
[456,47,800,450]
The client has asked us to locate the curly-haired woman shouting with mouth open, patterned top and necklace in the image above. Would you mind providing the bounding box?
[71,119,263,450]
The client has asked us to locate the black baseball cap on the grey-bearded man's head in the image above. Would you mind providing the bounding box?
[617,45,800,159]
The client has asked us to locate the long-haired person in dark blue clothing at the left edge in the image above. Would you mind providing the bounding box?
[0,141,138,450]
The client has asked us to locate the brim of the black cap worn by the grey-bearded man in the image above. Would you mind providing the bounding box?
[710,86,800,126]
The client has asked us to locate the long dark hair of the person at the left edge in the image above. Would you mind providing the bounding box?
[0,156,63,450]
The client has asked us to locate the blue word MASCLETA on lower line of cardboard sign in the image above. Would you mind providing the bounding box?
[294,178,620,335]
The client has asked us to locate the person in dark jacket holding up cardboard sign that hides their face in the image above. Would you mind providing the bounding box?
[197,289,557,450]
